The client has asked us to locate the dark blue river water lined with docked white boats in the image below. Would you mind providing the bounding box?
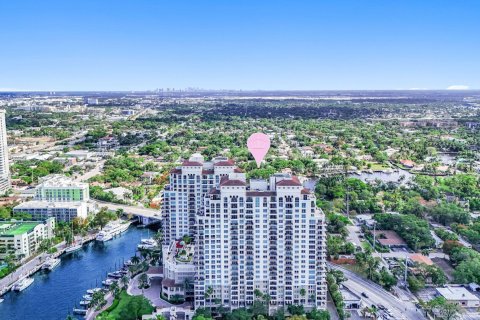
[0,227,152,320]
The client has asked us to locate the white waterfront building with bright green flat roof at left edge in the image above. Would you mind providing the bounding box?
[0,218,55,260]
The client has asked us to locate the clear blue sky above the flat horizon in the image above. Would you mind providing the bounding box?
[0,0,480,91]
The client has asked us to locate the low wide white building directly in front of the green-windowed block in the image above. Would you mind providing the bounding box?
[13,200,88,221]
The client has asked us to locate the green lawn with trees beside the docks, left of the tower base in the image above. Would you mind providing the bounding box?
[102,290,155,320]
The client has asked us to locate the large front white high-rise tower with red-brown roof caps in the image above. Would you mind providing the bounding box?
[194,172,327,311]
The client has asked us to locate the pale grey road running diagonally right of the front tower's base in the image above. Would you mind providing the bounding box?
[327,263,425,320]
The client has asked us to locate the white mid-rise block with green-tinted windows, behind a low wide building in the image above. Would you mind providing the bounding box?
[35,174,90,202]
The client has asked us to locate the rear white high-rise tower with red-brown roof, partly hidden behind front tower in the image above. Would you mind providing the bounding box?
[162,154,245,244]
